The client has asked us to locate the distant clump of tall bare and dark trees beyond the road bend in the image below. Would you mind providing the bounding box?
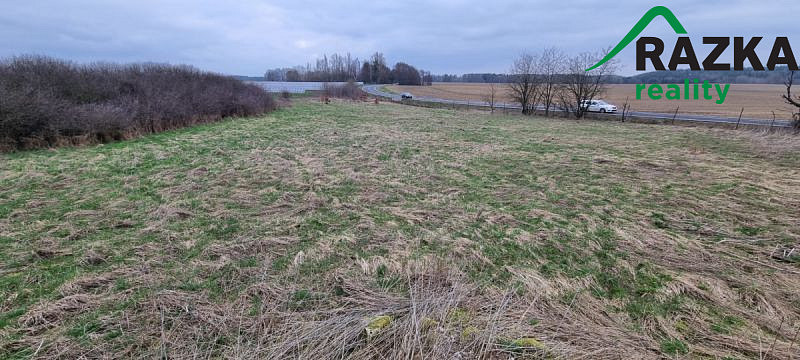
[264,52,432,85]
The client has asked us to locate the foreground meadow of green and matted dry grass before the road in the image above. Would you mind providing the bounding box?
[0,100,800,359]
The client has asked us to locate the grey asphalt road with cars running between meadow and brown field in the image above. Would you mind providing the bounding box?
[362,85,790,127]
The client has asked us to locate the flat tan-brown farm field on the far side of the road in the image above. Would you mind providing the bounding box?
[387,83,792,120]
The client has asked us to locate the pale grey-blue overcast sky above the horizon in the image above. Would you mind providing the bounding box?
[0,0,800,75]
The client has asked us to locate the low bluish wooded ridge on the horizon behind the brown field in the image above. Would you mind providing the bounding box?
[432,67,788,84]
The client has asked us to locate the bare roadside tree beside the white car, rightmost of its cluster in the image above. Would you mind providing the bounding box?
[557,52,616,119]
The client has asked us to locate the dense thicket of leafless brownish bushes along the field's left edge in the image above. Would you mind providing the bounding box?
[0,56,275,150]
